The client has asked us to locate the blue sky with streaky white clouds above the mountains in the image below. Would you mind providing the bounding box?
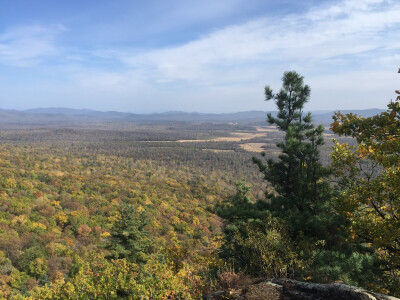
[0,0,400,113]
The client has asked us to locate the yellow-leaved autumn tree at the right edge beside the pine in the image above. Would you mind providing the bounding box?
[331,69,400,292]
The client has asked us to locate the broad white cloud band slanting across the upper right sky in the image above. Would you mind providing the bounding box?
[102,0,400,90]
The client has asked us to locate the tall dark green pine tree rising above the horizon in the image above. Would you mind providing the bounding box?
[253,71,374,285]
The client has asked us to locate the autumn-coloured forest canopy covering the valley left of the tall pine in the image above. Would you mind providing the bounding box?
[0,124,261,299]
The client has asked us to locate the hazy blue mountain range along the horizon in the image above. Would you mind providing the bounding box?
[0,108,384,125]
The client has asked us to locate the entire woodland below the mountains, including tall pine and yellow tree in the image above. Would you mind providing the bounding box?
[0,72,400,299]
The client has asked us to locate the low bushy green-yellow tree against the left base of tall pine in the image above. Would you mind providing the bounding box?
[217,181,300,277]
